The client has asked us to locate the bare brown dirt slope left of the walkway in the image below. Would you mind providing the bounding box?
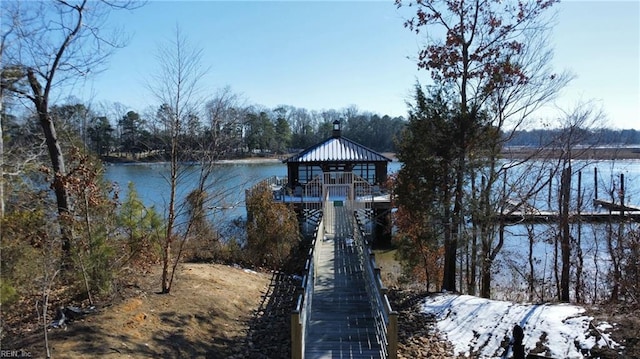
[13,264,271,358]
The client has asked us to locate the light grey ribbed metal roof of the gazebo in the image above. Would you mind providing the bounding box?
[282,136,392,163]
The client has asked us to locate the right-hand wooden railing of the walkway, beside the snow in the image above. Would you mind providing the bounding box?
[353,211,398,359]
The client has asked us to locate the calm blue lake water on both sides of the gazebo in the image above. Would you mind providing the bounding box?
[106,160,640,299]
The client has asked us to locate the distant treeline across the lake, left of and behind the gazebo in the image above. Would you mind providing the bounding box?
[2,102,406,161]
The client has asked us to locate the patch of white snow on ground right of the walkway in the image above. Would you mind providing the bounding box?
[423,294,615,358]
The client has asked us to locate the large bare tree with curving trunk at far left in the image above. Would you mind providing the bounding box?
[2,0,138,256]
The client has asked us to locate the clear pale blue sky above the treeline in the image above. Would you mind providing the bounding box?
[83,0,640,129]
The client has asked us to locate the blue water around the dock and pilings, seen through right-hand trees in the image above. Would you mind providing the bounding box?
[493,160,640,302]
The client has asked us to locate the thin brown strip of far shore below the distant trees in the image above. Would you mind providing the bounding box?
[102,145,640,164]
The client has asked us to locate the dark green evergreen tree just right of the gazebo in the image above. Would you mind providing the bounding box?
[395,85,457,289]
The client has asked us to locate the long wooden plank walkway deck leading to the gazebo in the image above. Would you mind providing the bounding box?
[305,207,382,359]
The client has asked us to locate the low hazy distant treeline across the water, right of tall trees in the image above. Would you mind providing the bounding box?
[506,129,640,147]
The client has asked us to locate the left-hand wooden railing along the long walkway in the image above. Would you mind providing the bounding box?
[291,218,324,359]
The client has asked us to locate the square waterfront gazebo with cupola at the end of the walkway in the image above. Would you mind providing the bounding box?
[282,120,393,243]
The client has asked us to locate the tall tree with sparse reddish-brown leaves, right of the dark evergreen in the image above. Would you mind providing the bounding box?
[396,0,570,296]
